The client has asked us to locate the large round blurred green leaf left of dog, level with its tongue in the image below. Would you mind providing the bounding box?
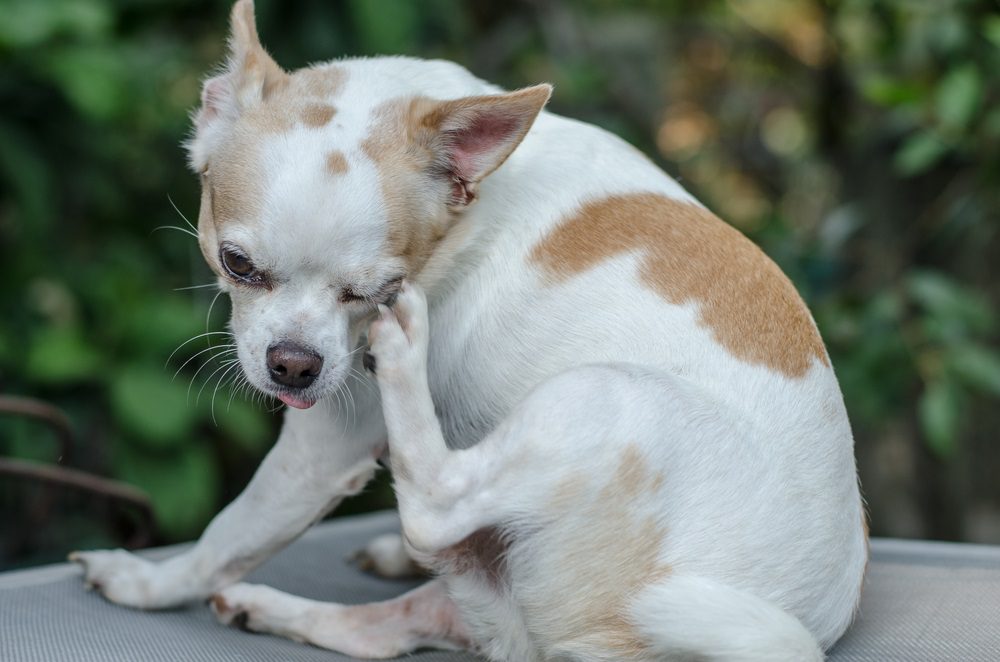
[111,365,198,449]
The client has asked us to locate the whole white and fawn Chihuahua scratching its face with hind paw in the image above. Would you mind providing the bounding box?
[73,0,867,662]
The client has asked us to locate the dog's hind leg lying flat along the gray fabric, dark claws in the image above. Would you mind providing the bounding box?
[211,580,471,658]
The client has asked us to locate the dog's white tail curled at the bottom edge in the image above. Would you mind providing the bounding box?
[632,576,823,662]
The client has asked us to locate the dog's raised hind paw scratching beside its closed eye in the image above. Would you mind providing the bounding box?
[368,281,427,383]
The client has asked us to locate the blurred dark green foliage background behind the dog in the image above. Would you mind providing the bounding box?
[0,0,1000,567]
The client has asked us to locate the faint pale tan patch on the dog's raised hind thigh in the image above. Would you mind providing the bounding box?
[550,444,671,660]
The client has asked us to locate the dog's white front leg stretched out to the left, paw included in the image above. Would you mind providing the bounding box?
[70,389,385,609]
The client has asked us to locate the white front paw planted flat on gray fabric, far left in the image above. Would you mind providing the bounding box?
[69,549,160,609]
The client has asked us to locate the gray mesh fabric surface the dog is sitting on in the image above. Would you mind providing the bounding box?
[0,513,1000,662]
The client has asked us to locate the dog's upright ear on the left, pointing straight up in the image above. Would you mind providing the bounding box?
[194,0,288,139]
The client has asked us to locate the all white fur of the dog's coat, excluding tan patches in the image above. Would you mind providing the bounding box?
[75,7,866,662]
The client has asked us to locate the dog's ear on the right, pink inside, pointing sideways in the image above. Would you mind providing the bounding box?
[415,84,552,207]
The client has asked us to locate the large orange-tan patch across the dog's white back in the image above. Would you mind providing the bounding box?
[531,193,829,377]
